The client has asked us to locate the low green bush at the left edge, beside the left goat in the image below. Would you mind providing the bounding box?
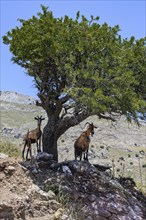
[0,141,21,158]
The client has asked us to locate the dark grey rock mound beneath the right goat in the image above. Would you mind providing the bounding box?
[45,161,146,220]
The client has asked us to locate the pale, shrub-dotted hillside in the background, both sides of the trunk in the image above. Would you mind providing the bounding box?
[0,92,146,191]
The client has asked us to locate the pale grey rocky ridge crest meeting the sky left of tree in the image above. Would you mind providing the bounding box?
[0,91,35,105]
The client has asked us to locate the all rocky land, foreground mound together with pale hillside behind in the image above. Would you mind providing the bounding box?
[0,92,146,220]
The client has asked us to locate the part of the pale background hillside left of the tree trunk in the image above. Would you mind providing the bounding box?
[0,91,45,143]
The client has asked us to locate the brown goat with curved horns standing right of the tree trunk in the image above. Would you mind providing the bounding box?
[74,122,97,161]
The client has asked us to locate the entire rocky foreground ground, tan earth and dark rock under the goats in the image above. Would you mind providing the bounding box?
[0,153,146,220]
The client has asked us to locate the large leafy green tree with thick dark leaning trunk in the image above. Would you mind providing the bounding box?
[3,5,146,161]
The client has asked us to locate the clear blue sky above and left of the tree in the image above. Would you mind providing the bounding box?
[0,0,146,97]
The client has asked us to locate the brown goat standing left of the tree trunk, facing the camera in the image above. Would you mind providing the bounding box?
[22,115,45,159]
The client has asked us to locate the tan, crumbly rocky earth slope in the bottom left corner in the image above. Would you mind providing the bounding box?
[0,157,62,220]
